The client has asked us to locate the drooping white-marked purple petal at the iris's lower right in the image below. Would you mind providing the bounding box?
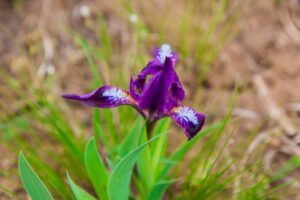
[169,106,205,140]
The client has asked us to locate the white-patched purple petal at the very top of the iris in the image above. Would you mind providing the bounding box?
[153,44,178,66]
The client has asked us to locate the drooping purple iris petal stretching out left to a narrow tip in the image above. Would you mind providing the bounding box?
[63,86,136,108]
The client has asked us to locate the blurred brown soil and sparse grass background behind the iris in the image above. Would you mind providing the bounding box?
[0,0,300,199]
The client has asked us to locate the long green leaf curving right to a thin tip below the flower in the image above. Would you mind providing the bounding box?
[107,135,161,200]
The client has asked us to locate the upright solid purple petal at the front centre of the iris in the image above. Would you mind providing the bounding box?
[139,57,175,113]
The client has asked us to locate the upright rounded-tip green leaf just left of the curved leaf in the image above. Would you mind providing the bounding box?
[84,138,109,200]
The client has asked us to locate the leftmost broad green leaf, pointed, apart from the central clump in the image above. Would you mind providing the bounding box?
[19,152,53,200]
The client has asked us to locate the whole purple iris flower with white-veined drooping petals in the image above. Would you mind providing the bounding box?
[63,44,205,139]
